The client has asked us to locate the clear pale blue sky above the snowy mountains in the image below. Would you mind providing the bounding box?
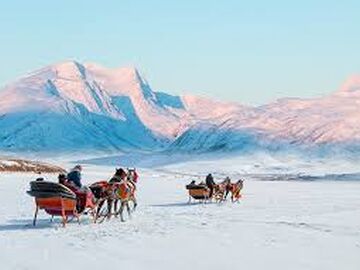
[0,0,360,104]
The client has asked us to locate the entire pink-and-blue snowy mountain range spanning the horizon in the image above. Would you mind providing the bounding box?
[0,61,360,153]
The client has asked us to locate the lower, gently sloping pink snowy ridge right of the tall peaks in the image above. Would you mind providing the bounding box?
[171,76,360,154]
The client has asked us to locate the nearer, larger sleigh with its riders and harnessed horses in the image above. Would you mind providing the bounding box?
[28,165,138,226]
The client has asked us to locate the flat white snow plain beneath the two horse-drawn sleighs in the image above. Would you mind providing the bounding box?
[0,160,360,270]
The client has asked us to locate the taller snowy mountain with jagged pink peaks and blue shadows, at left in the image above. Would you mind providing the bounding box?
[0,61,240,151]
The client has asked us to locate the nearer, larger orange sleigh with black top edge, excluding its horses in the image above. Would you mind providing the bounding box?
[27,181,96,226]
